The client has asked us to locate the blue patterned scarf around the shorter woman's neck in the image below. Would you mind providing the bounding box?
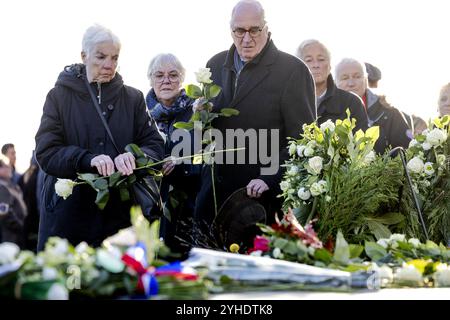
[146,89,193,136]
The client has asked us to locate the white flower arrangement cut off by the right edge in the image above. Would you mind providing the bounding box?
[403,116,450,243]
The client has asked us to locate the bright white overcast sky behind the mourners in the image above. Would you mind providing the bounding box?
[0,0,450,171]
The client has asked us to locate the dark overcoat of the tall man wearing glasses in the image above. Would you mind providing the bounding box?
[198,39,316,224]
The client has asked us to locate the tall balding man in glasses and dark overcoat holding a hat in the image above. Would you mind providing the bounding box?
[197,0,316,245]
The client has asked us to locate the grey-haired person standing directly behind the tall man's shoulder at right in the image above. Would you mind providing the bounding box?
[297,39,368,130]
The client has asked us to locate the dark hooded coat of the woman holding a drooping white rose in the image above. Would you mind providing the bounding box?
[36,65,163,250]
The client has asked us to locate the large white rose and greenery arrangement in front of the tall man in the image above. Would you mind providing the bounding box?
[280,113,404,242]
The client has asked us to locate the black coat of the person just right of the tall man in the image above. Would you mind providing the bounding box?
[317,75,368,131]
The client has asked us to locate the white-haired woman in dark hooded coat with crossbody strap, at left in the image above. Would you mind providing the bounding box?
[36,25,164,250]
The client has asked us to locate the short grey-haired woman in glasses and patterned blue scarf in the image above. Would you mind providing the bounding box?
[146,53,200,252]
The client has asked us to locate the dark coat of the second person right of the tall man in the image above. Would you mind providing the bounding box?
[366,90,411,154]
